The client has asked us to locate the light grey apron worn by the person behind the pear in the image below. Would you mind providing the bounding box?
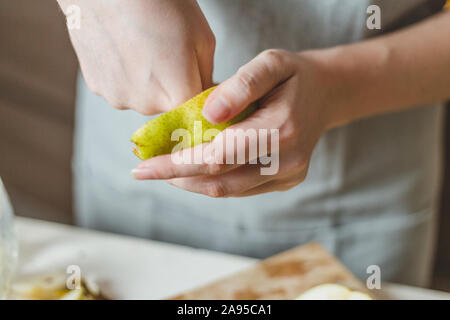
[74,0,443,284]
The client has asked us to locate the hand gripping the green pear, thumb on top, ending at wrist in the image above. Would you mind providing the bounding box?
[133,50,334,197]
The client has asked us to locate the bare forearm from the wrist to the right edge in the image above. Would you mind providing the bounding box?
[314,12,450,128]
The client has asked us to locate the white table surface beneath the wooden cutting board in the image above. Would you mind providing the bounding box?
[12,218,450,299]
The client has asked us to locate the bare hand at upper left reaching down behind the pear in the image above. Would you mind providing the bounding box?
[58,0,215,115]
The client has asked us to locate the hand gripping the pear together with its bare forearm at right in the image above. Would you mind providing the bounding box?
[133,12,450,197]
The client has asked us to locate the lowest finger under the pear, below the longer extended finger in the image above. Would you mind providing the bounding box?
[167,165,274,198]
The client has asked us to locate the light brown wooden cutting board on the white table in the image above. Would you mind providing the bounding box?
[173,243,368,300]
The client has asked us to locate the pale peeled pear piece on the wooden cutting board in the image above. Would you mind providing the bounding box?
[295,284,373,300]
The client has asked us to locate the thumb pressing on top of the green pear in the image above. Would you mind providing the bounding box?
[203,50,294,123]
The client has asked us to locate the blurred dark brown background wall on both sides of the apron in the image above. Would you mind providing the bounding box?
[0,0,450,291]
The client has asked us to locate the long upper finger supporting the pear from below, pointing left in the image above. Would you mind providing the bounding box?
[132,97,298,180]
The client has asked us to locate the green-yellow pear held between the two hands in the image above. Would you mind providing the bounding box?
[131,87,257,160]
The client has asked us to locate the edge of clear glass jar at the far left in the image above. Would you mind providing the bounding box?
[0,178,18,299]
